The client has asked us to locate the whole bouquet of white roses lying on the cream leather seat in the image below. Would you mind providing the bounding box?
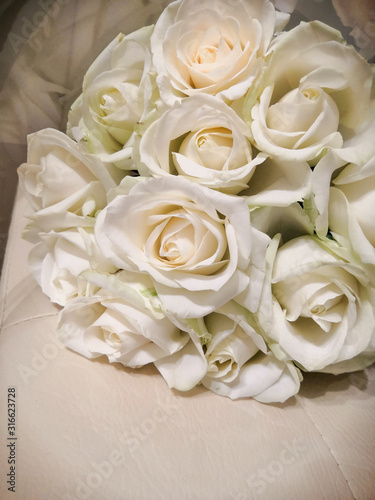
[19,0,375,402]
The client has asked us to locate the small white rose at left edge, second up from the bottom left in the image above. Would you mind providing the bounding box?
[29,227,115,306]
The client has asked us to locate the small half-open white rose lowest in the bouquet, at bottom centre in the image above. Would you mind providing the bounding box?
[202,304,300,403]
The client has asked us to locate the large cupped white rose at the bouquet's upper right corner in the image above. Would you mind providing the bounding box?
[245,21,372,163]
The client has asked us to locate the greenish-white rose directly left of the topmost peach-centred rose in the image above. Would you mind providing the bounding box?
[68,26,156,169]
